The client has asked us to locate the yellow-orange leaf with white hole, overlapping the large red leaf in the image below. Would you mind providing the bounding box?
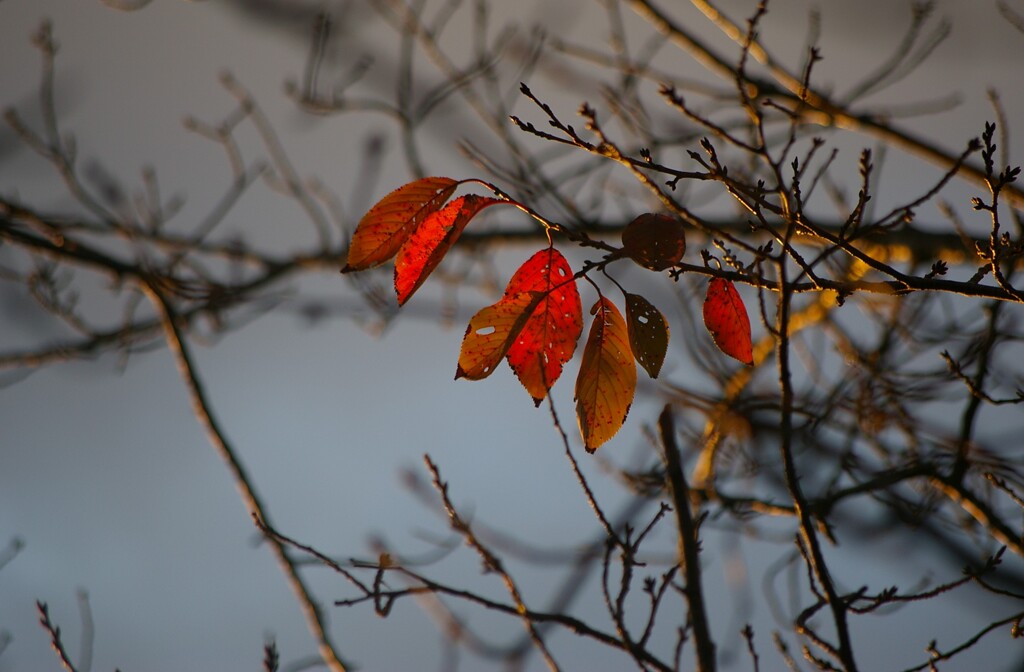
[455,293,542,380]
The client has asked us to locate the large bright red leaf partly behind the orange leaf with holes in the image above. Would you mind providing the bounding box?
[505,247,583,406]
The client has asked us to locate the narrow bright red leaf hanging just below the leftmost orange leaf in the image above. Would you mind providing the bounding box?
[394,195,505,305]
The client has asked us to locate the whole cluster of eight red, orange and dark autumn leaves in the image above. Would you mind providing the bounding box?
[342,177,754,453]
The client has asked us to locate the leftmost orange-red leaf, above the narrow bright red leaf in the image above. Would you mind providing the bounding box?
[341,177,459,272]
